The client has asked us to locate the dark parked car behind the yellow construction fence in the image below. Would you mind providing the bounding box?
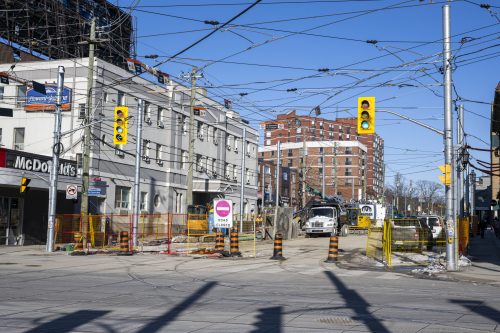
[391,218,434,251]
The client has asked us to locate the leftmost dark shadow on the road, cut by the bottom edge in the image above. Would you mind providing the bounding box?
[26,310,110,333]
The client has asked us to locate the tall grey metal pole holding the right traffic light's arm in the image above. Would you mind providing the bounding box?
[443,5,458,271]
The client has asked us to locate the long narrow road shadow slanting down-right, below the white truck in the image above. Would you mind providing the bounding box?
[325,271,389,333]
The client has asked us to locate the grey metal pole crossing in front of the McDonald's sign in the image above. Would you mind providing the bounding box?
[46,66,64,252]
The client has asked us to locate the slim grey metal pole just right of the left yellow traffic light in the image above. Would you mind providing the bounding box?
[132,99,144,246]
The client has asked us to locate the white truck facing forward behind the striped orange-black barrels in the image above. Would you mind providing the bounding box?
[304,206,339,237]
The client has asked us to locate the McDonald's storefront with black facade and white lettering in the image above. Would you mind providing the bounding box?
[0,148,80,245]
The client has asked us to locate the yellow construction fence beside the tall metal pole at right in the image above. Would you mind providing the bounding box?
[366,218,470,267]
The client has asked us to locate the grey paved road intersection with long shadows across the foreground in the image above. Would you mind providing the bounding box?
[0,239,500,333]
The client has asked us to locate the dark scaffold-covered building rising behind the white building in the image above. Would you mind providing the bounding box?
[0,0,134,67]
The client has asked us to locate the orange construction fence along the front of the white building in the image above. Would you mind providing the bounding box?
[55,213,265,256]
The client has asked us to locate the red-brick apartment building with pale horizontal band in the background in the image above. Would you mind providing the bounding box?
[259,111,384,206]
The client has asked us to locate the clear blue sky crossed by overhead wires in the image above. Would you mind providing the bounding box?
[115,0,500,184]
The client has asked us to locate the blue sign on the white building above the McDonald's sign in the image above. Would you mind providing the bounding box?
[24,84,72,111]
